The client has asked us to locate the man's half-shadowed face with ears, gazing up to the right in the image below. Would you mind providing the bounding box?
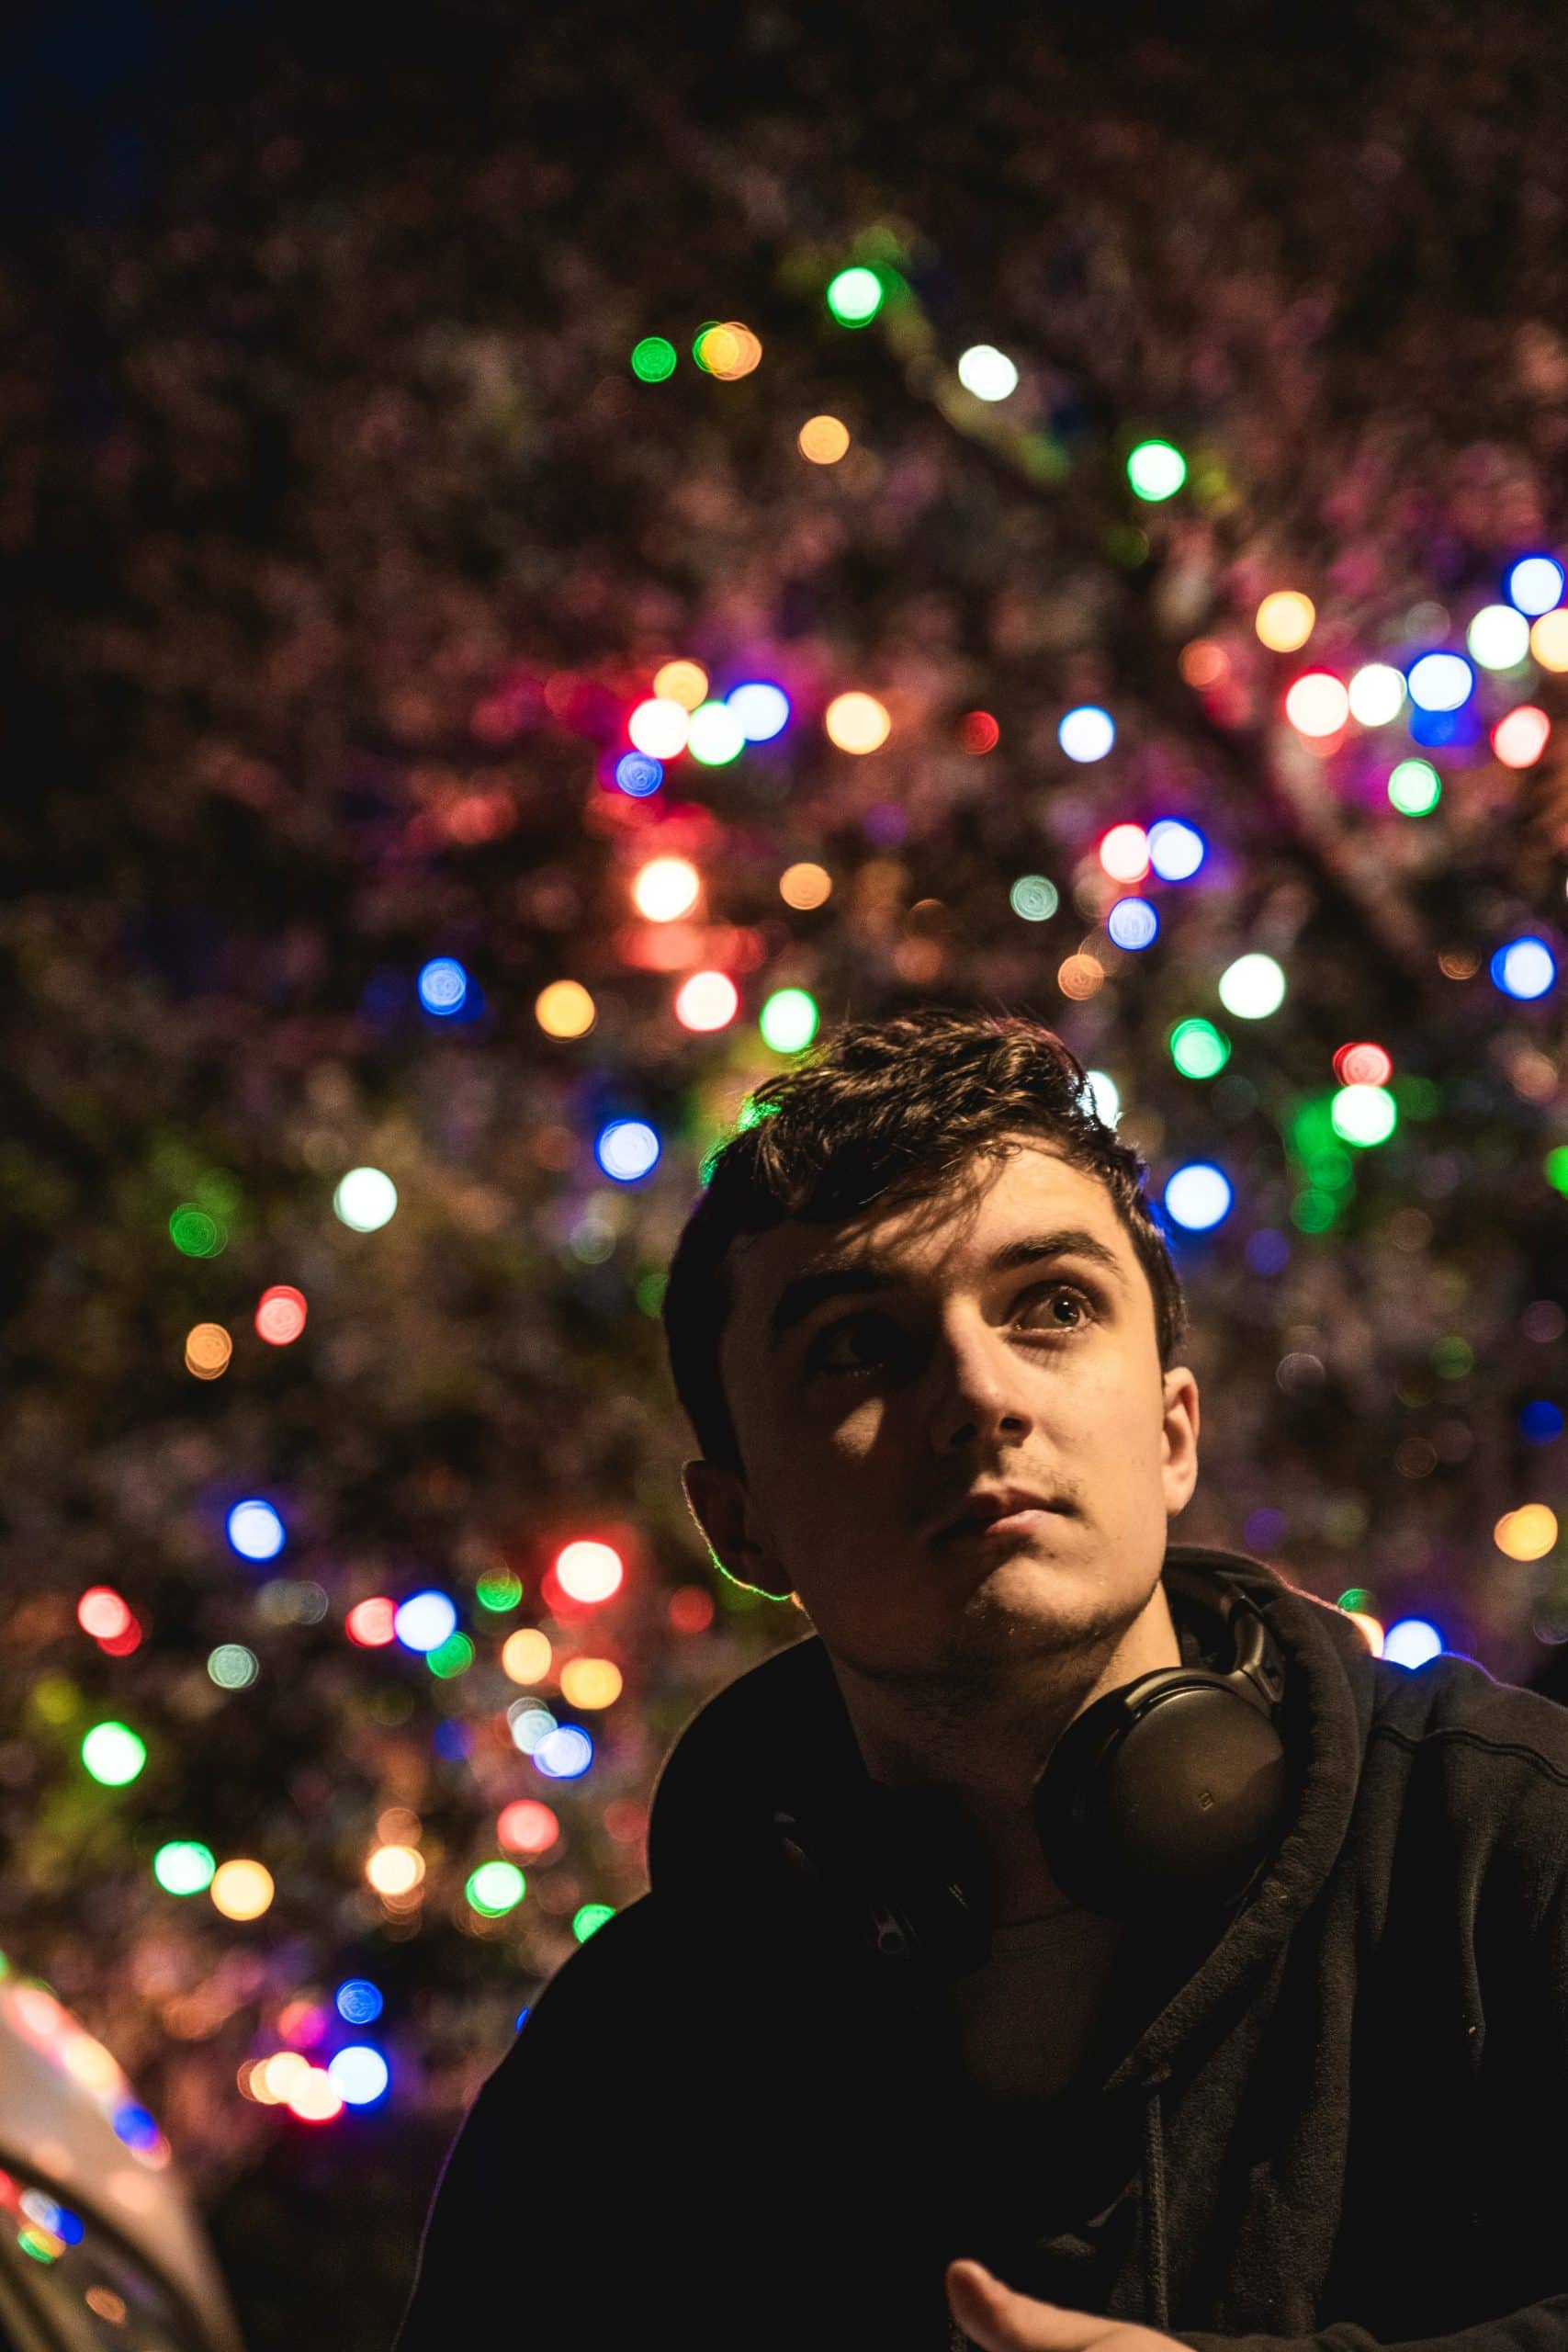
[684,1138,1199,1749]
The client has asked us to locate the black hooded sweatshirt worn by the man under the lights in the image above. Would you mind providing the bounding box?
[398,1545,1568,2352]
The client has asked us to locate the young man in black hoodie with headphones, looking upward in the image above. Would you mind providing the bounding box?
[400,1012,1568,2352]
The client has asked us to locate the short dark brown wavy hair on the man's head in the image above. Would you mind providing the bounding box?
[663,1007,1187,1473]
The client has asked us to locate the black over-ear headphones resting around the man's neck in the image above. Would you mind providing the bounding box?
[773,1559,1288,1975]
